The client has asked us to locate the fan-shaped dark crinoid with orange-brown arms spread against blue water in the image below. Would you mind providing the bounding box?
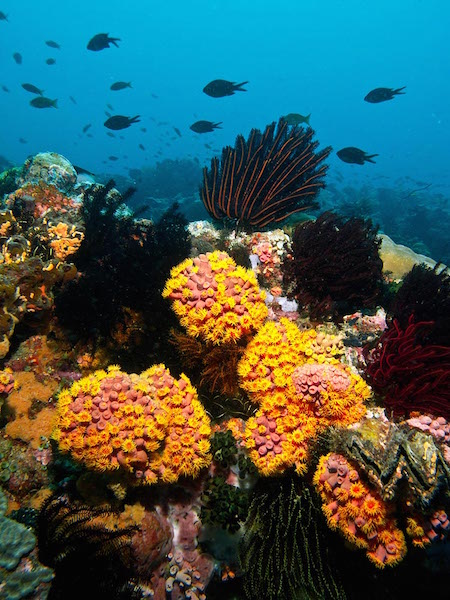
[200,119,331,227]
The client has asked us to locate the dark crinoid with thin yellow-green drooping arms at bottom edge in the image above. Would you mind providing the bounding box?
[239,476,346,600]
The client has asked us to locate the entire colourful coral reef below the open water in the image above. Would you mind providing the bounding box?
[0,152,450,600]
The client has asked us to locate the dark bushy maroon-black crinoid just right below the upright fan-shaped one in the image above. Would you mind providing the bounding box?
[283,212,383,321]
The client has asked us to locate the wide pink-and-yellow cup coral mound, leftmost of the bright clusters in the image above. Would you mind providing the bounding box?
[53,364,211,484]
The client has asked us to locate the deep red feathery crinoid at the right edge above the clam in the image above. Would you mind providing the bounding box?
[366,315,450,419]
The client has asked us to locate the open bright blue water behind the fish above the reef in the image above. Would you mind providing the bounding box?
[0,0,450,187]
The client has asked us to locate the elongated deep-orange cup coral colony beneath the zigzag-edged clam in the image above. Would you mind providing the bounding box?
[314,453,406,568]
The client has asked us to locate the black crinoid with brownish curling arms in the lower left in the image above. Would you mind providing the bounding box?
[37,496,142,600]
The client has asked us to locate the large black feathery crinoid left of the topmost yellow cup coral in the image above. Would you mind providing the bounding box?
[56,181,190,370]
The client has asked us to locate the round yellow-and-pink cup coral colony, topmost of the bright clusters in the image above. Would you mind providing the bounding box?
[163,251,268,344]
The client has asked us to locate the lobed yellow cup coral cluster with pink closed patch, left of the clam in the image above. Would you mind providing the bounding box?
[238,319,370,475]
